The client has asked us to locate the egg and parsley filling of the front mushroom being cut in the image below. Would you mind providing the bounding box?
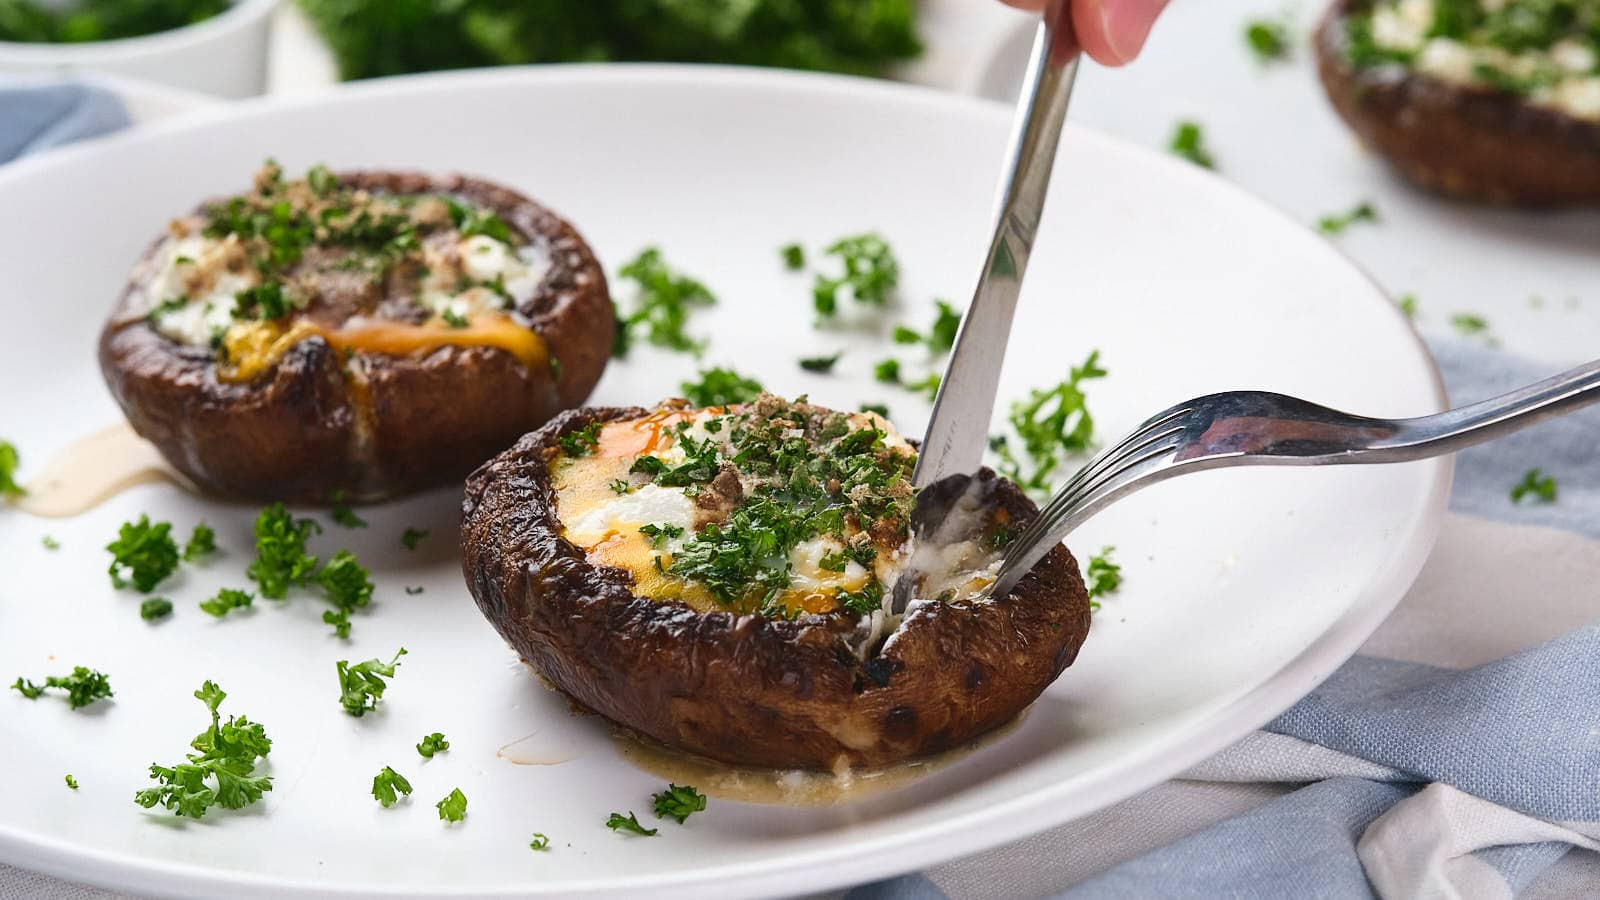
[552,394,997,621]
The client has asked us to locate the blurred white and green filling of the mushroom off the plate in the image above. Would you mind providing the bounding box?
[1347,0,1600,122]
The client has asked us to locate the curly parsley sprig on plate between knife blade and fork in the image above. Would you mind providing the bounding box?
[989,351,1106,493]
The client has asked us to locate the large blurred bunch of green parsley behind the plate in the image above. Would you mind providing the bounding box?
[299,0,922,78]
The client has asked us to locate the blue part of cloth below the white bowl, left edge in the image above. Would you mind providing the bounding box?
[0,78,130,163]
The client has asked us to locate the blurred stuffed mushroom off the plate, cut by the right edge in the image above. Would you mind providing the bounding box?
[1317,0,1600,205]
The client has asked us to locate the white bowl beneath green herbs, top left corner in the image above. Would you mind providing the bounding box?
[0,0,277,98]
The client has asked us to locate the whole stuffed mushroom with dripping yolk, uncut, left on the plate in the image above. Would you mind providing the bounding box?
[99,163,614,503]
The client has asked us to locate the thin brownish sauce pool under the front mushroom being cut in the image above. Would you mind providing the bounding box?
[613,709,1027,806]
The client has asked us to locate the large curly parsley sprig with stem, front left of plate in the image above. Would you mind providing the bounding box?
[133,681,272,818]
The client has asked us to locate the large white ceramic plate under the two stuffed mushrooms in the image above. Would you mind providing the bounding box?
[0,67,1450,897]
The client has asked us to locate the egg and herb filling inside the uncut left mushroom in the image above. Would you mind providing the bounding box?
[134,163,550,381]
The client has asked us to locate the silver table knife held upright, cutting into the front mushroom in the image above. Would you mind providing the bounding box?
[912,0,1080,488]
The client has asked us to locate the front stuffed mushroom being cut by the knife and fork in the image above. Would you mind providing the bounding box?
[462,394,1090,769]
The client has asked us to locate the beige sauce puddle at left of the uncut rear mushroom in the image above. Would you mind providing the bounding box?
[16,423,189,519]
